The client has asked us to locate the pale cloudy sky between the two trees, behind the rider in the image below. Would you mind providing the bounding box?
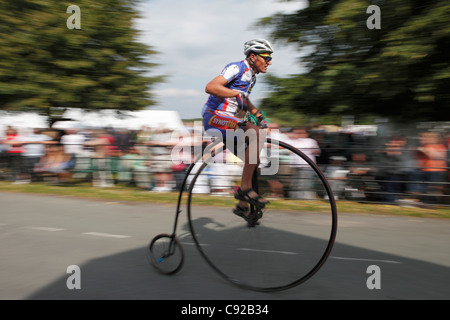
[136,0,307,119]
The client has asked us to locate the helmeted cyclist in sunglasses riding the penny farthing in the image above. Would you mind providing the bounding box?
[202,39,273,222]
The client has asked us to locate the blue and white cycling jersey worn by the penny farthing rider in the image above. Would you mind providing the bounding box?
[202,60,256,116]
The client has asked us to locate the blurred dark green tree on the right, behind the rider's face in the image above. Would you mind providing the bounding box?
[258,0,450,121]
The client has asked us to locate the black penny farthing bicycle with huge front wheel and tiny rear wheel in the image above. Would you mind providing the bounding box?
[148,119,337,292]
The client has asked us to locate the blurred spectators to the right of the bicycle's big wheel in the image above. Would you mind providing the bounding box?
[312,126,450,206]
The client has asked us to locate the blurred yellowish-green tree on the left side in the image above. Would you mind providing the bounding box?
[0,0,162,114]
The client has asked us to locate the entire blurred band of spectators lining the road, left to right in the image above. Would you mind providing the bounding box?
[0,123,450,206]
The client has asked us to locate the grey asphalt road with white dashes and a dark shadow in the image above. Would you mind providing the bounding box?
[0,193,450,301]
